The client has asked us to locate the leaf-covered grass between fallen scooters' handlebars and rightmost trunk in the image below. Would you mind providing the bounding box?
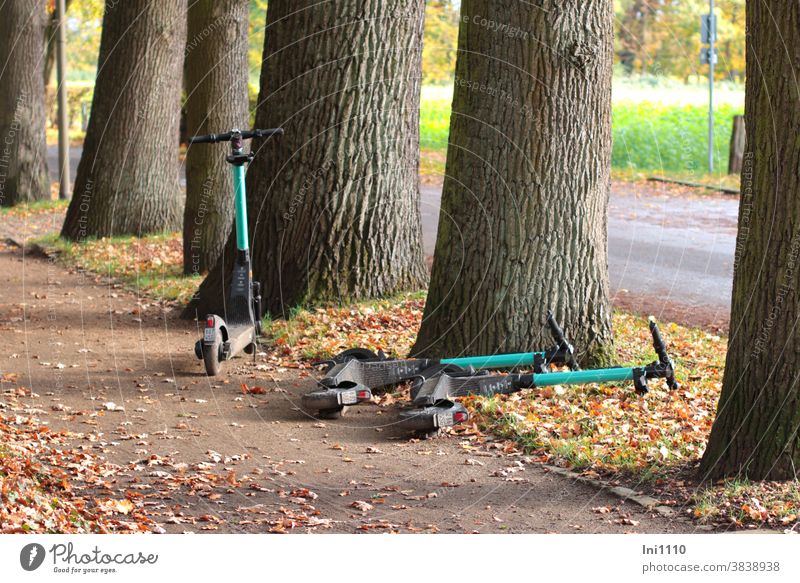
[476,313,725,479]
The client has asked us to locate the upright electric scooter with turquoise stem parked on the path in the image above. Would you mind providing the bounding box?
[189,128,283,376]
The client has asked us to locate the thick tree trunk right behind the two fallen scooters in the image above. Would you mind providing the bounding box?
[414,0,613,363]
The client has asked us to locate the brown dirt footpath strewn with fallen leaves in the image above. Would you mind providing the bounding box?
[0,244,693,533]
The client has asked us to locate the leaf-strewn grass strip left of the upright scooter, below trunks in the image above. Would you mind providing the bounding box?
[35,233,202,303]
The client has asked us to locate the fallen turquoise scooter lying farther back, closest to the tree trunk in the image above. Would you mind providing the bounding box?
[302,313,578,419]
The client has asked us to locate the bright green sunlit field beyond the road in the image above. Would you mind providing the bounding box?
[420,81,744,175]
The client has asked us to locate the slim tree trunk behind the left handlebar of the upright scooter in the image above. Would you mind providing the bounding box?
[183,0,249,274]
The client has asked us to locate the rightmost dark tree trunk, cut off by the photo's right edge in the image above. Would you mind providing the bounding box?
[701,0,800,480]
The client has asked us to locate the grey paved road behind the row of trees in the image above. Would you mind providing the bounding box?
[48,146,739,328]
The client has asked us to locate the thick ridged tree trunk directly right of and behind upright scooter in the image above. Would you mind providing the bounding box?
[187,0,426,316]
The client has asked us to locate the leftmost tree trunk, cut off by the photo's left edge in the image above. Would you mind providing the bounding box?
[0,0,50,206]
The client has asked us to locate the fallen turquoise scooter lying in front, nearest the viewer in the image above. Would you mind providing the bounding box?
[399,318,678,434]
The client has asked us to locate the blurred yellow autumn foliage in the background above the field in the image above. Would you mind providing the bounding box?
[50,0,745,85]
